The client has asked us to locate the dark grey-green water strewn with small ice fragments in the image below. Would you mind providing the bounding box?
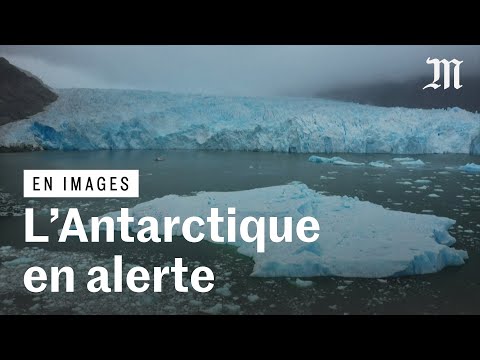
[0,150,480,314]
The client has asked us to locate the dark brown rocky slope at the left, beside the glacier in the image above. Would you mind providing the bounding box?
[0,57,58,126]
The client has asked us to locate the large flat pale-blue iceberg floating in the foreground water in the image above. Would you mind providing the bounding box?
[86,182,468,278]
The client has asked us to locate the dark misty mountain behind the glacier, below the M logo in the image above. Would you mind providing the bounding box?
[316,76,480,112]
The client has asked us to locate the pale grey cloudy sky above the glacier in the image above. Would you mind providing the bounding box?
[0,45,480,96]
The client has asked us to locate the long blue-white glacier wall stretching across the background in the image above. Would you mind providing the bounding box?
[0,89,480,154]
